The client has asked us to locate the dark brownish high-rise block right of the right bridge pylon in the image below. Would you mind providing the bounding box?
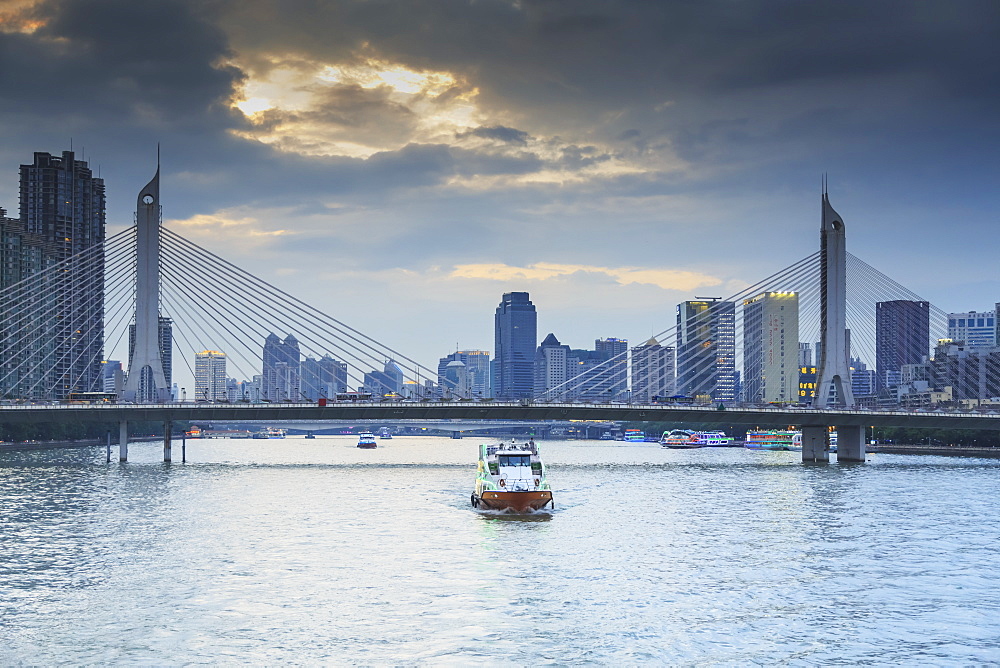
[875,299,931,390]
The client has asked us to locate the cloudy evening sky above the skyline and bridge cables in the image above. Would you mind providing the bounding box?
[0,0,1000,376]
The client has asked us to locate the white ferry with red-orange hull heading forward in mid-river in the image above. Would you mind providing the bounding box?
[471,439,555,513]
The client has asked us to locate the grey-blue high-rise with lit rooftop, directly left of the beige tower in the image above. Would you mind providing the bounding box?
[677,299,737,402]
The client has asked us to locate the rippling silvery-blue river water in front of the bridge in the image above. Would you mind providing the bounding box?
[0,437,1000,665]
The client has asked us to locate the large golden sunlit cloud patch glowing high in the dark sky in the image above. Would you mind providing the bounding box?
[231,51,677,184]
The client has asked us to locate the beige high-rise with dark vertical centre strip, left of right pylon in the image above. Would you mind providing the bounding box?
[743,292,800,403]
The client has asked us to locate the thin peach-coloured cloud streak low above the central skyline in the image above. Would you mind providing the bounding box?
[450,262,723,291]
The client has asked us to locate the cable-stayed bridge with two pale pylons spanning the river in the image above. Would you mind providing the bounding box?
[0,164,1000,461]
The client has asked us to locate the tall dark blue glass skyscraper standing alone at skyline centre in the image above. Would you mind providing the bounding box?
[493,292,538,399]
